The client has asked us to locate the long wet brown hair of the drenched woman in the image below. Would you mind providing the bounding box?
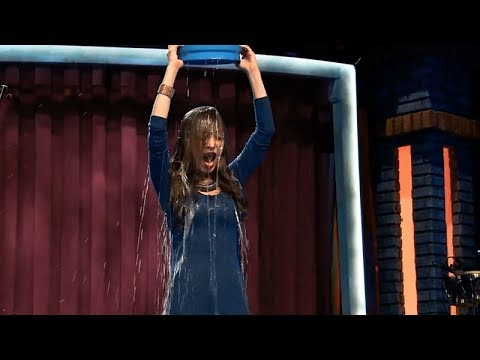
[170,106,247,224]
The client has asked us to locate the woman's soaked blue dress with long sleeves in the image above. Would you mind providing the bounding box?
[148,97,275,315]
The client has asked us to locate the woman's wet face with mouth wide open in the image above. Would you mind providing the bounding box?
[194,130,225,175]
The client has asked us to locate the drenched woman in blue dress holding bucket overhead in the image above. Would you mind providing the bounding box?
[148,45,275,314]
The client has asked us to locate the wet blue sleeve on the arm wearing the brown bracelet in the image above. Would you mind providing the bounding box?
[148,115,170,212]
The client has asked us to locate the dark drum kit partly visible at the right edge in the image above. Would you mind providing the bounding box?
[444,258,480,315]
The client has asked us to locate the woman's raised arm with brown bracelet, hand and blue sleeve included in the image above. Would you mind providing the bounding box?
[148,45,183,212]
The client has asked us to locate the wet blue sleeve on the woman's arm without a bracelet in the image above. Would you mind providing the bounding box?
[229,97,275,186]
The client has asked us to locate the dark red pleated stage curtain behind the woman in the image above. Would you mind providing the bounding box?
[0,64,339,314]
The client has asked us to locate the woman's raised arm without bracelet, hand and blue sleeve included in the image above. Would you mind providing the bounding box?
[230,45,275,185]
